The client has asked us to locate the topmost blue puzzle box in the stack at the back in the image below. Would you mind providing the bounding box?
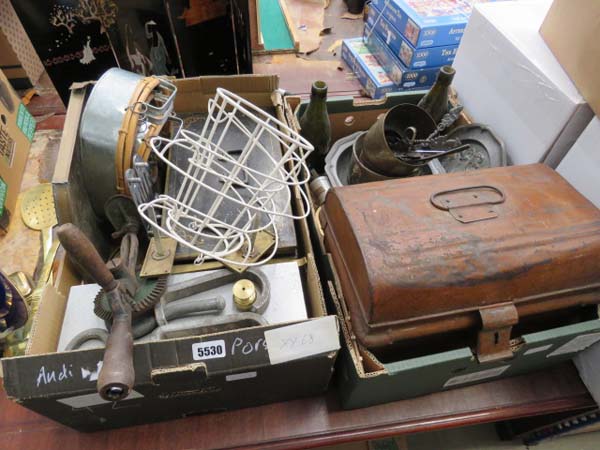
[371,0,497,49]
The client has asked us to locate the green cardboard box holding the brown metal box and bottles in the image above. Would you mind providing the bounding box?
[285,91,600,409]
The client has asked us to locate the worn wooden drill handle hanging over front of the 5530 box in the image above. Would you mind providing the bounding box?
[97,290,135,401]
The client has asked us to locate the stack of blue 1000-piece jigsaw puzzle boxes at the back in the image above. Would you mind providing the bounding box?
[342,0,495,98]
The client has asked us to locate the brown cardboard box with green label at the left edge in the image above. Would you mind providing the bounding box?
[0,70,35,234]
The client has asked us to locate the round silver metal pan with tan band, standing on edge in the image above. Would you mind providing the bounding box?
[79,68,177,217]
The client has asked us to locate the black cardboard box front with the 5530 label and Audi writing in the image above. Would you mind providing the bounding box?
[2,316,340,399]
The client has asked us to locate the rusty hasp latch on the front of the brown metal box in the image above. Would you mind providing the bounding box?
[477,303,519,363]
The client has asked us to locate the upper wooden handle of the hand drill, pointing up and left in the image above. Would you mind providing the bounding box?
[56,223,117,292]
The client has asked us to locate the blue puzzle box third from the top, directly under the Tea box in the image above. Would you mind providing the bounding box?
[366,33,439,90]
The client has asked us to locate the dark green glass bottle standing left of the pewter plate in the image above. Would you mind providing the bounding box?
[299,81,331,173]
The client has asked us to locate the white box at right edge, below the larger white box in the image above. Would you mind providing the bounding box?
[556,117,600,208]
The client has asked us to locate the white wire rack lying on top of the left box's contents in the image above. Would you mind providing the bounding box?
[138,88,313,266]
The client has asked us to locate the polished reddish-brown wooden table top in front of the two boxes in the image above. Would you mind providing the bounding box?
[0,363,594,450]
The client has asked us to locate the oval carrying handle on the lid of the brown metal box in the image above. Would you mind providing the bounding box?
[429,185,506,223]
